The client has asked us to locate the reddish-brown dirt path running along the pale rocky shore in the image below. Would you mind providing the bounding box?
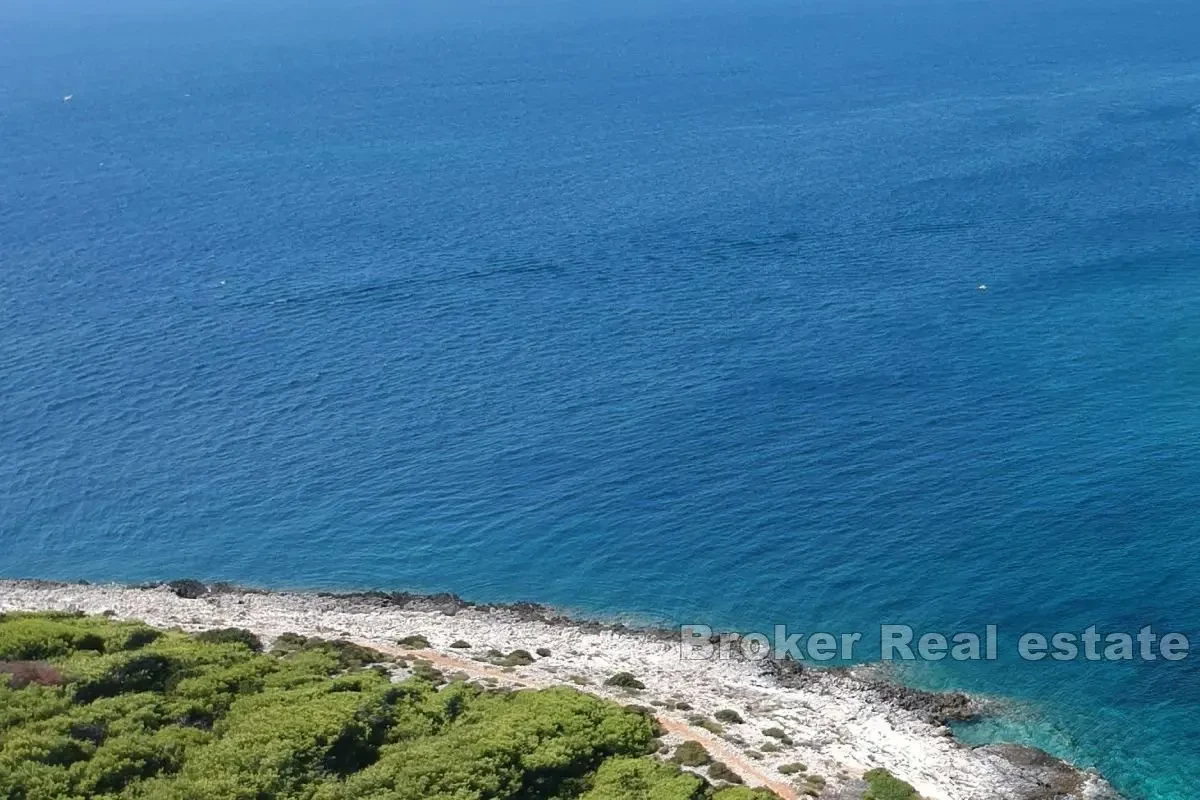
[376,642,799,800]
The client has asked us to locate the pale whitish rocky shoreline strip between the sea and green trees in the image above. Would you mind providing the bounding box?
[0,579,1118,800]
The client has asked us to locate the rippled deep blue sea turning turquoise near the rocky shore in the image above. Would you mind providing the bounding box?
[0,0,1200,800]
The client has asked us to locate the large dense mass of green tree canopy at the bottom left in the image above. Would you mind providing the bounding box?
[0,614,763,800]
